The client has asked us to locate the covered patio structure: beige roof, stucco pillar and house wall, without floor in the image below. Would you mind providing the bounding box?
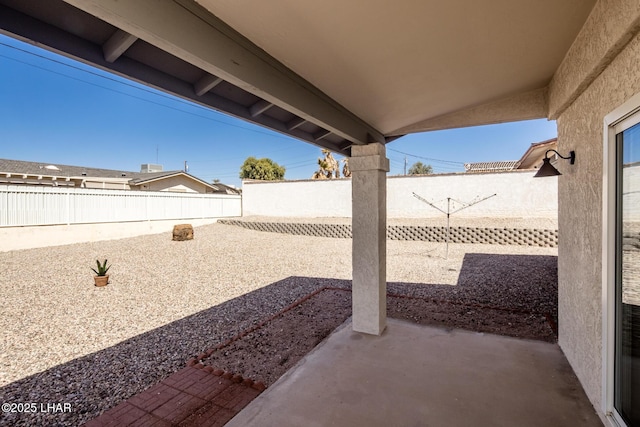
[0,0,640,425]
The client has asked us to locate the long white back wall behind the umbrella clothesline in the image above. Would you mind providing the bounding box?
[242,171,558,221]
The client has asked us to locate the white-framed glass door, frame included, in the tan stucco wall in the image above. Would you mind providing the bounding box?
[602,94,640,427]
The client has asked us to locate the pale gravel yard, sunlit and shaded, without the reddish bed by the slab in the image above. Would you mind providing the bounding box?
[0,220,557,425]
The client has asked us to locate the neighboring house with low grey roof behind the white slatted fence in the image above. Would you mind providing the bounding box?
[0,159,239,194]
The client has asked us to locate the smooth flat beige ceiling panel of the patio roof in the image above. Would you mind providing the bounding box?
[197,0,595,135]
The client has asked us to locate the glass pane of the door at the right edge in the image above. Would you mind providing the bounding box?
[615,124,640,427]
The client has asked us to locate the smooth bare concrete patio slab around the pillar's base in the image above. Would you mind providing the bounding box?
[227,319,602,427]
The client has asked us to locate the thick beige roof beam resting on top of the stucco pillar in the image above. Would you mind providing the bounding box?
[64,0,386,144]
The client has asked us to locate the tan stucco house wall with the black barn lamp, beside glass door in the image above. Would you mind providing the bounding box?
[557,30,640,415]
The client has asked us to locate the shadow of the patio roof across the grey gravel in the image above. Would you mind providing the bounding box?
[0,254,557,426]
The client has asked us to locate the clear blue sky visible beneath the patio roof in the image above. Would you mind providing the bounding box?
[0,35,557,186]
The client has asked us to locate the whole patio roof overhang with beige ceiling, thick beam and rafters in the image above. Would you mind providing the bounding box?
[0,0,600,155]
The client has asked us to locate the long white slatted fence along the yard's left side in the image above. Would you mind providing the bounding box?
[0,185,242,227]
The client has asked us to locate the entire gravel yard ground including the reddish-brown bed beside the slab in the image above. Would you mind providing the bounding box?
[0,220,557,425]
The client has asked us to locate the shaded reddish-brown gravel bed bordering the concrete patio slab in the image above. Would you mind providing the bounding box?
[198,288,557,386]
